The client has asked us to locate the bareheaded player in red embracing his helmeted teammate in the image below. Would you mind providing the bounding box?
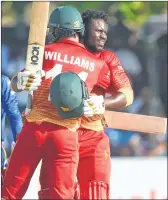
[39,10,133,199]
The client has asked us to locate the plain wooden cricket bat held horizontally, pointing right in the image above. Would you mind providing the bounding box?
[104,111,167,134]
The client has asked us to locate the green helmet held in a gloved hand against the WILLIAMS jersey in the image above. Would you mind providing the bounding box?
[50,72,89,119]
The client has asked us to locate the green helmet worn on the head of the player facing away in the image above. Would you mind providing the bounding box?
[48,6,84,43]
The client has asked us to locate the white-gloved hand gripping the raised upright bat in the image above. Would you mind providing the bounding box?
[17,70,45,91]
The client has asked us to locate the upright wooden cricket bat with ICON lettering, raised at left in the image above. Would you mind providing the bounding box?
[25,1,49,72]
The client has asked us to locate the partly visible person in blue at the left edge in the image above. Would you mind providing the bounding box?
[1,74,23,184]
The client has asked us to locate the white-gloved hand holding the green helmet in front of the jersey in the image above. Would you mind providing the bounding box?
[84,95,105,117]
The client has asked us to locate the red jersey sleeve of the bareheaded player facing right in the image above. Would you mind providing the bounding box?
[97,51,134,106]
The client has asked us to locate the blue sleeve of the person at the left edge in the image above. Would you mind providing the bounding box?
[1,77,23,141]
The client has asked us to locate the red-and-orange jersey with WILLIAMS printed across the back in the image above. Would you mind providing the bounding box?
[27,40,104,129]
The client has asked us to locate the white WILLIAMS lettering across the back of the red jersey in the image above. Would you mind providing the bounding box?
[45,51,96,72]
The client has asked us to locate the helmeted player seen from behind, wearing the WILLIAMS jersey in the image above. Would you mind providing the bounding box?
[2,6,109,199]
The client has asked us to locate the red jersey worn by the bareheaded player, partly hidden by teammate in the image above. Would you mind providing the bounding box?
[81,50,132,130]
